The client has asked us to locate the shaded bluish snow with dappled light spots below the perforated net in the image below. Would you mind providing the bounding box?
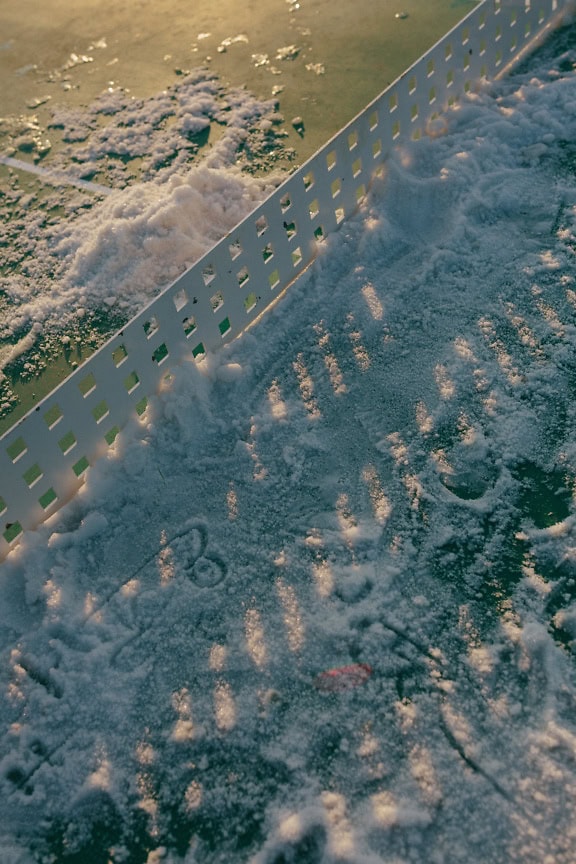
[0,18,576,864]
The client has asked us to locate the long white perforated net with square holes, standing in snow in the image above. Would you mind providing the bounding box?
[0,0,574,560]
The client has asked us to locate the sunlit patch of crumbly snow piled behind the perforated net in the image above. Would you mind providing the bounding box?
[0,69,283,416]
